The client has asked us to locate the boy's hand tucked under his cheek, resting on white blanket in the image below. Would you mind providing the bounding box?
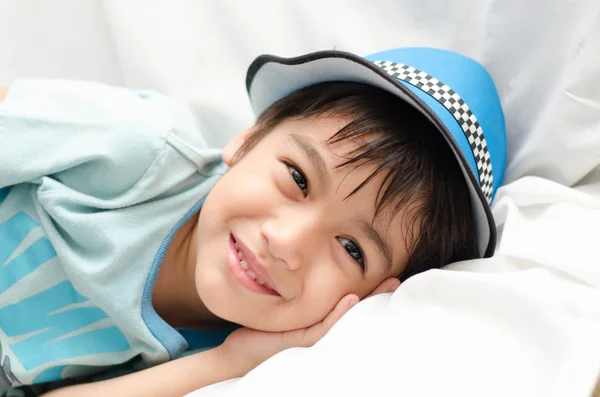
[219,278,400,377]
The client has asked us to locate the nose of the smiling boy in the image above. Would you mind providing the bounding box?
[261,214,318,270]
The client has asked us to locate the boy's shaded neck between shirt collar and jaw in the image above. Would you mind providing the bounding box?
[152,215,221,328]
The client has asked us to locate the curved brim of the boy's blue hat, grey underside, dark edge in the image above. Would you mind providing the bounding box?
[246,51,496,258]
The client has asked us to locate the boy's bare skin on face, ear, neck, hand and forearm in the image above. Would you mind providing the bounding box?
[0,83,408,397]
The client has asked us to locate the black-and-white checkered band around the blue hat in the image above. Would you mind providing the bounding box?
[373,61,494,204]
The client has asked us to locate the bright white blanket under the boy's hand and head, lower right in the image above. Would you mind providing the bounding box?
[190,178,600,397]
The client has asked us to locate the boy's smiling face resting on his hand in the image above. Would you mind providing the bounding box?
[196,118,408,331]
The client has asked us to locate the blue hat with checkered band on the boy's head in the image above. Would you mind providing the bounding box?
[246,48,506,257]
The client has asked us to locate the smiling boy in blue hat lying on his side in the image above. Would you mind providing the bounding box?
[0,48,505,397]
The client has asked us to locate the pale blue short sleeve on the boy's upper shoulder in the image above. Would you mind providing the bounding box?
[0,79,195,197]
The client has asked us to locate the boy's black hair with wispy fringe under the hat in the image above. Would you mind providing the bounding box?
[234,82,479,281]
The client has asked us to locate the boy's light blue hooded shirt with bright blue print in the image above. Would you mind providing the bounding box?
[0,79,226,388]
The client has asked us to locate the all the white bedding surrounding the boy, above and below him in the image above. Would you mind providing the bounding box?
[0,0,600,397]
